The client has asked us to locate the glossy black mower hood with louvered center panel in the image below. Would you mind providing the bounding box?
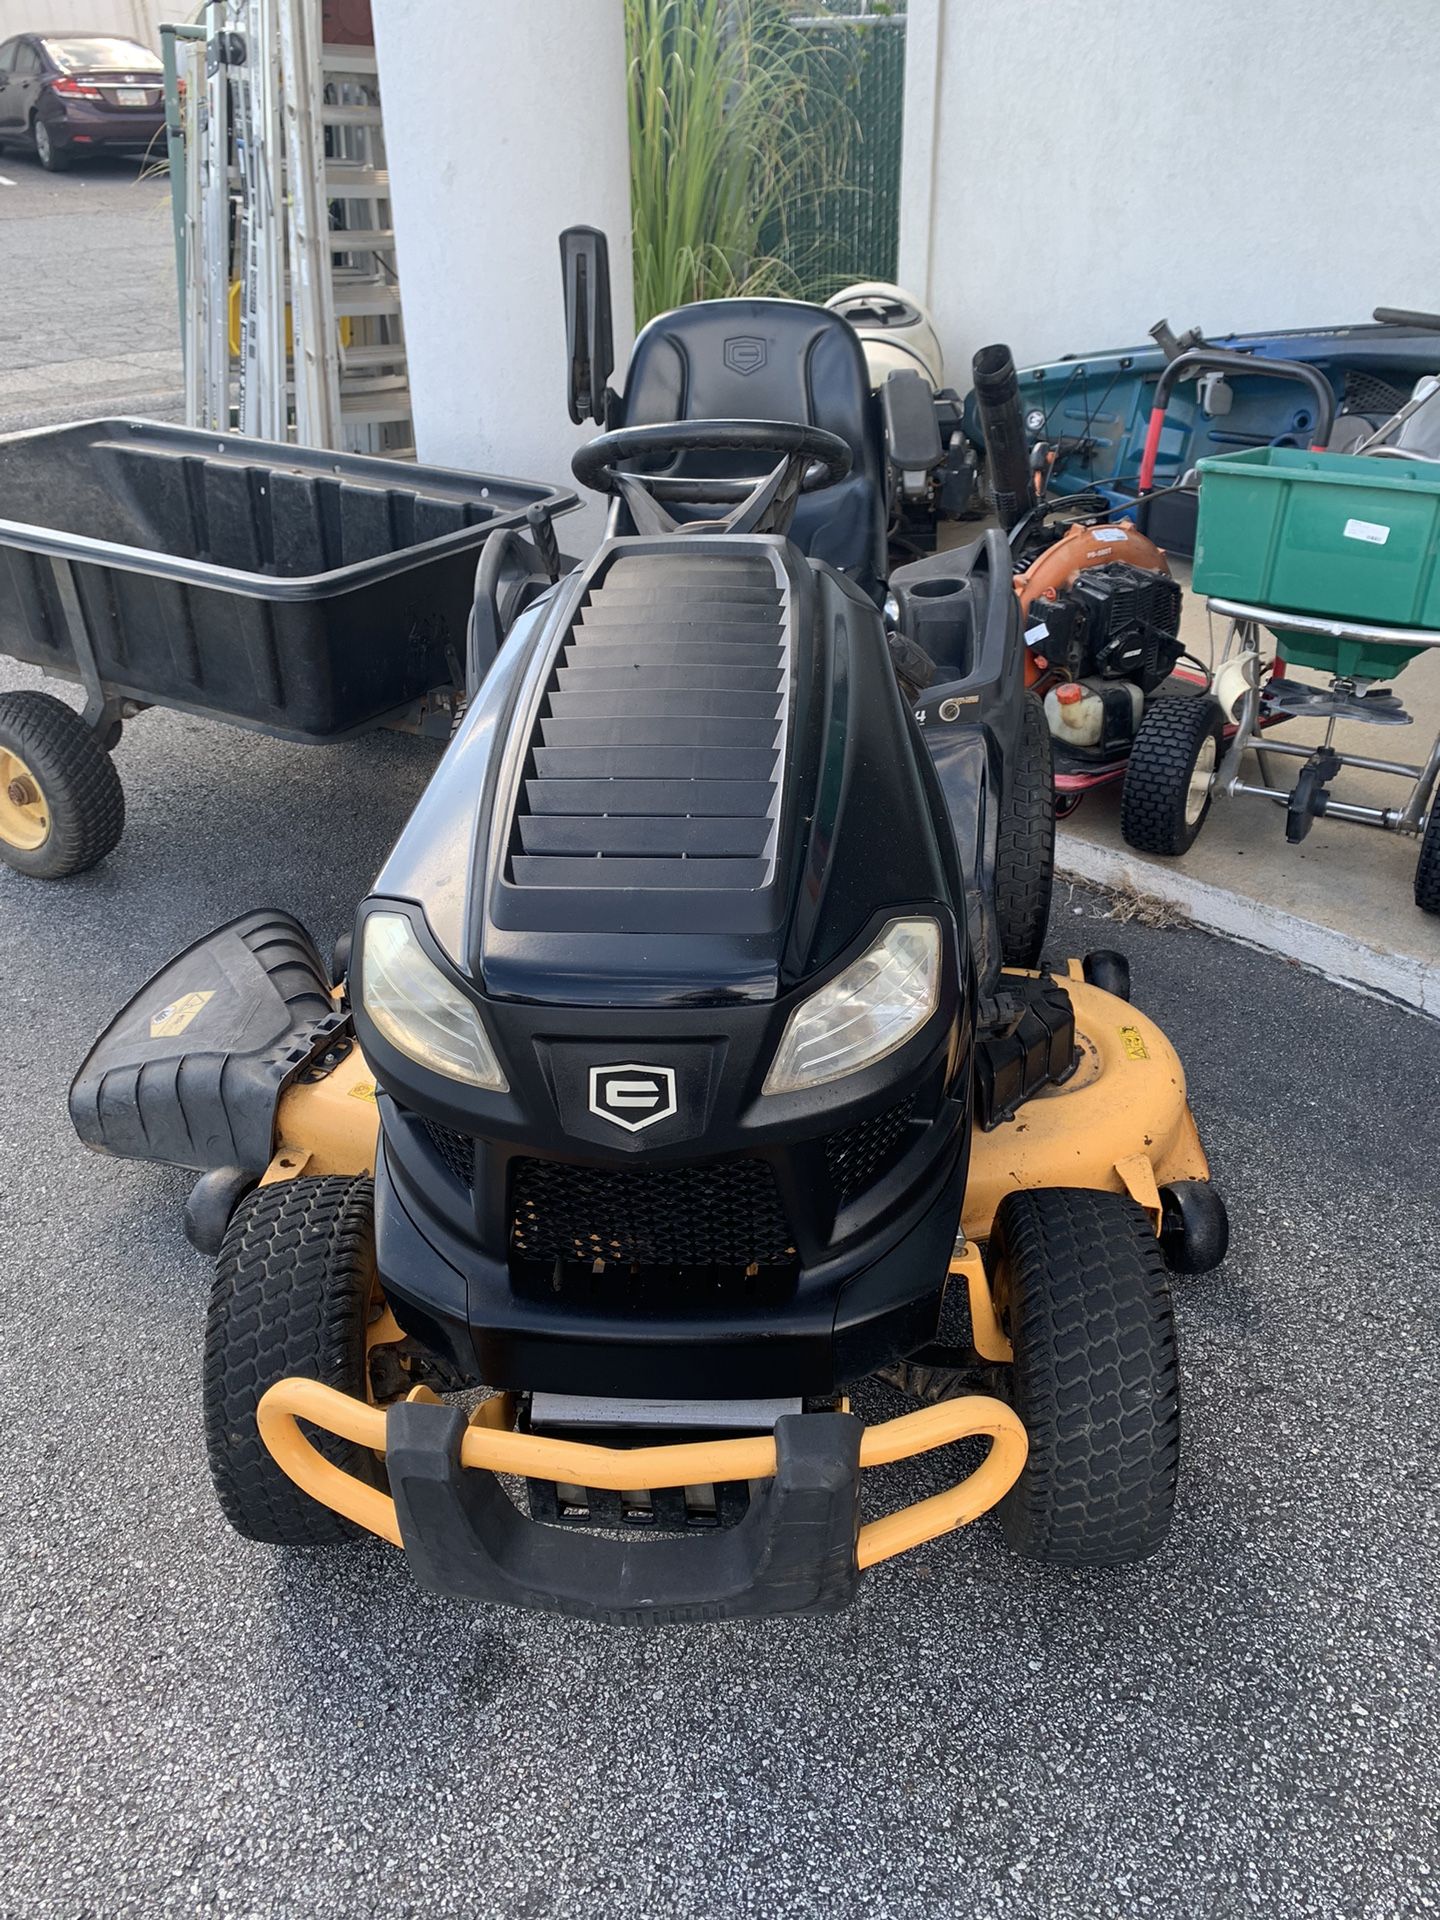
[367,534,962,1006]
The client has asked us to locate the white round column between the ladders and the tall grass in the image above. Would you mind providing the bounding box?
[374,0,634,553]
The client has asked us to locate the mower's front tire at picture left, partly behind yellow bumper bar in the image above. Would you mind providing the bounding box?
[204,1177,382,1548]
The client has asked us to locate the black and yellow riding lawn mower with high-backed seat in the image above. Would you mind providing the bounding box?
[71,230,1227,1624]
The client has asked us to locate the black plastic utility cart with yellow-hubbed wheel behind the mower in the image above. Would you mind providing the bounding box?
[0,420,576,879]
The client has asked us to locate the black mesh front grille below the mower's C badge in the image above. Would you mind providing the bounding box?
[511,1160,795,1267]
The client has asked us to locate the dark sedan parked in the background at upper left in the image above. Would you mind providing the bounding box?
[0,33,165,173]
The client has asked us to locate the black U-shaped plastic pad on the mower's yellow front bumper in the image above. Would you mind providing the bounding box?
[386,1402,864,1626]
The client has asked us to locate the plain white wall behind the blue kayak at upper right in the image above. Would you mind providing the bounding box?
[900,0,1440,392]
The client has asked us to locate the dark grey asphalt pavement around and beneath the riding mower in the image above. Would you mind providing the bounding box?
[0,648,1440,1920]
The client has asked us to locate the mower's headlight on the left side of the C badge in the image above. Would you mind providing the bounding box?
[361,914,509,1092]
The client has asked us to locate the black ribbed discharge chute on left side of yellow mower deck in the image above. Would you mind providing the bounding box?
[69,912,349,1173]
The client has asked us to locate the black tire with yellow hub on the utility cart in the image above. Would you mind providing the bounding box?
[0,691,125,879]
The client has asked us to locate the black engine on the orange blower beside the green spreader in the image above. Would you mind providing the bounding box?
[1029,561,1181,693]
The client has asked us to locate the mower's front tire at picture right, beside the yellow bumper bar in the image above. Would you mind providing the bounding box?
[991,1188,1181,1567]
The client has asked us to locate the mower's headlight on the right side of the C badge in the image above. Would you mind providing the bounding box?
[764,920,941,1092]
